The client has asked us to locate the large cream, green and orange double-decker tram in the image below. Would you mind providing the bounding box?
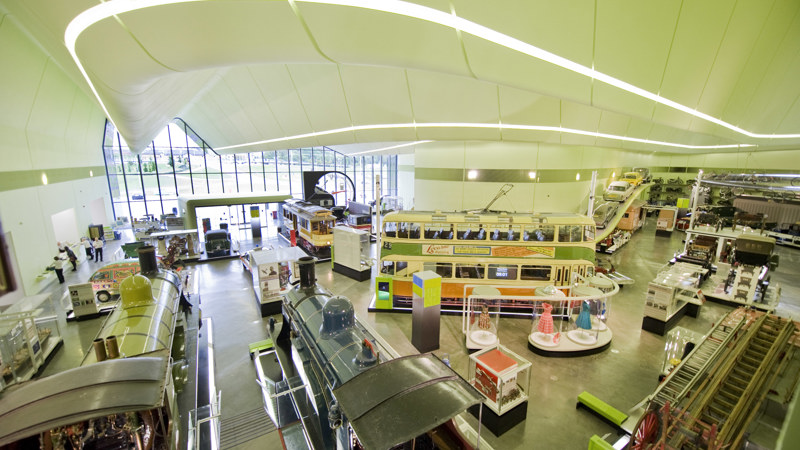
[374,211,595,310]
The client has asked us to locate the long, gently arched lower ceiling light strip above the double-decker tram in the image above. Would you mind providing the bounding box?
[216,122,755,151]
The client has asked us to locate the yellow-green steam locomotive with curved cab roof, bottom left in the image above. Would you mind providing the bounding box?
[0,246,209,450]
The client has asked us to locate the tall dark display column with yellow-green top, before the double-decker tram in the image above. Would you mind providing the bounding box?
[411,270,442,353]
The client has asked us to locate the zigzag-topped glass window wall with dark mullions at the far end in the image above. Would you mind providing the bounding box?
[103,119,397,222]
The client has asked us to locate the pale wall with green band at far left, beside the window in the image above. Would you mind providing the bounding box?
[0,12,111,300]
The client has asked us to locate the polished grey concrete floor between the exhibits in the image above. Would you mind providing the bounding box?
[29,219,800,449]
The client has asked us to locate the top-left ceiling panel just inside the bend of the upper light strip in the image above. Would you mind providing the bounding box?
[121,2,325,71]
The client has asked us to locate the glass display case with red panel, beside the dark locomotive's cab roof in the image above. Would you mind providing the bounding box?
[468,344,531,416]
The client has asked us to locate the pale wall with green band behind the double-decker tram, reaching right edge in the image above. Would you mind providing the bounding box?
[414,142,800,214]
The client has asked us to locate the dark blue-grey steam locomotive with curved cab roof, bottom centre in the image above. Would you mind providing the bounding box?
[255,257,482,449]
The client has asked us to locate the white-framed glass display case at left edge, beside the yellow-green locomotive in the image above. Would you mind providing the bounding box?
[0,294,62,386]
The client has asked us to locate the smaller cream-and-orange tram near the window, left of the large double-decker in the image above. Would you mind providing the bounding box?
[278,199,336,260]
